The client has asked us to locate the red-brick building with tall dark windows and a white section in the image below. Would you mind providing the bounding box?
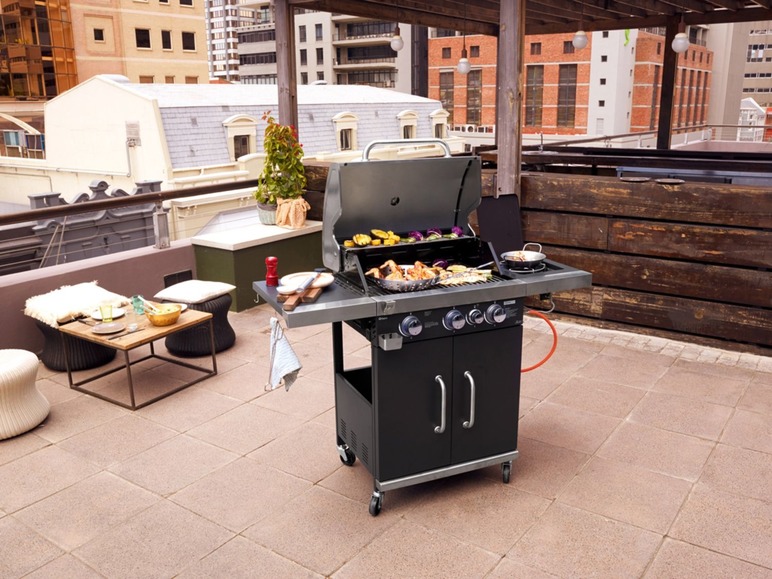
[429,28,712,139]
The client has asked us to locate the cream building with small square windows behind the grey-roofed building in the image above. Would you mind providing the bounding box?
[70,0,209,83]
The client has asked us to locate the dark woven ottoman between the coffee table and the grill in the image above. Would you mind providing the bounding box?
[166,293,236,358]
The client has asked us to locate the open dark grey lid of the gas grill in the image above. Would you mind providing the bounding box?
[322,156,482,271]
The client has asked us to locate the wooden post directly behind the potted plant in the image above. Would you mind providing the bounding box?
[273,0,298,129]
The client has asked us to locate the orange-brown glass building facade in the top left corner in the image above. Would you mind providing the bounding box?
[0,0,78,99]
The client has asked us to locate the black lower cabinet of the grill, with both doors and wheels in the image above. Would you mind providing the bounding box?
[334,317,522,502]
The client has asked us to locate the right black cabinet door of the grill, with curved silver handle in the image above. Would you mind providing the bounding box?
[450,326,523,464]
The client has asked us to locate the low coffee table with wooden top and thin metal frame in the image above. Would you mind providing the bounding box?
[59,308,217,410]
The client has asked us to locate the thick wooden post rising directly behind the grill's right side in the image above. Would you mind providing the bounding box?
[494,0,525,197]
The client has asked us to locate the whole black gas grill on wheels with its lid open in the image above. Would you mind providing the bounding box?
[253,141,591,515]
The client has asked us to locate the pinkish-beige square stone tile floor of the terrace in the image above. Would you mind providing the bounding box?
[0,306,772,579]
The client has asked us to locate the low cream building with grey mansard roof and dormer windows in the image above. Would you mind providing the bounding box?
[0,75,452,205]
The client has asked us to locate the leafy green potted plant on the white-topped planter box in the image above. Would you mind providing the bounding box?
[255,111,310,227]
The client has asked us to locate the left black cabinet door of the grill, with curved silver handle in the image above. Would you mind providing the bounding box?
[373,338,453,481]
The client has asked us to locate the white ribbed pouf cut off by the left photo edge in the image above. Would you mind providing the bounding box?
[0,350,51,440]
